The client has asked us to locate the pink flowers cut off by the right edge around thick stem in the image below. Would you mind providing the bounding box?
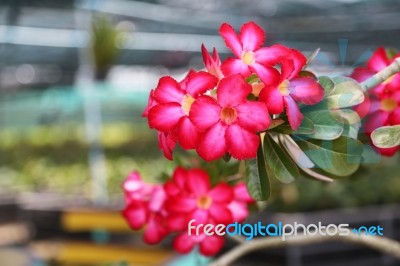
[351,47,400,156]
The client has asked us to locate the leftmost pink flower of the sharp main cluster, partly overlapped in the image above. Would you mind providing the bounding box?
[147,71,218,154]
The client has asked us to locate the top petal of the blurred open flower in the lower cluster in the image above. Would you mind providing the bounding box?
[186,169,211,196]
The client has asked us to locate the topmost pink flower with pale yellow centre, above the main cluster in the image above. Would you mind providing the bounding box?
[219,21,288,84]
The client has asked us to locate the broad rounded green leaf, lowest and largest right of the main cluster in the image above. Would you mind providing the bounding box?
[294,136,363,176]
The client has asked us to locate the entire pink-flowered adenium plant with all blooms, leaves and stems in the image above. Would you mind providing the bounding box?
[123,21,400,265]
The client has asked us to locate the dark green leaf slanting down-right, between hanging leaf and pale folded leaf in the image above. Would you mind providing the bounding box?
[264,134,299,183]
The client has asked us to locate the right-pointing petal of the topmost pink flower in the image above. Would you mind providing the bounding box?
[254,44,290,66]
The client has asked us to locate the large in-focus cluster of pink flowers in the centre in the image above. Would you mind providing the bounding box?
[143,22,324,161]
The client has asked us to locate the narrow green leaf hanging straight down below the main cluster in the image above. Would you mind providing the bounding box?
[245,143,271,200]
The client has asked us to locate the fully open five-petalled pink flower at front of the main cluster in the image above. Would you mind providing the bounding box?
[189,74,270,161]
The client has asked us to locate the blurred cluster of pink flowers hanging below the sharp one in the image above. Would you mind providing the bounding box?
[123,167,254,256]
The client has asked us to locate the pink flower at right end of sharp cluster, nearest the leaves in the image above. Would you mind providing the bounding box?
[259,49,324,130]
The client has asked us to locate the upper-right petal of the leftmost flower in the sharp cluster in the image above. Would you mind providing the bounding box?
[186,71,218,98]
